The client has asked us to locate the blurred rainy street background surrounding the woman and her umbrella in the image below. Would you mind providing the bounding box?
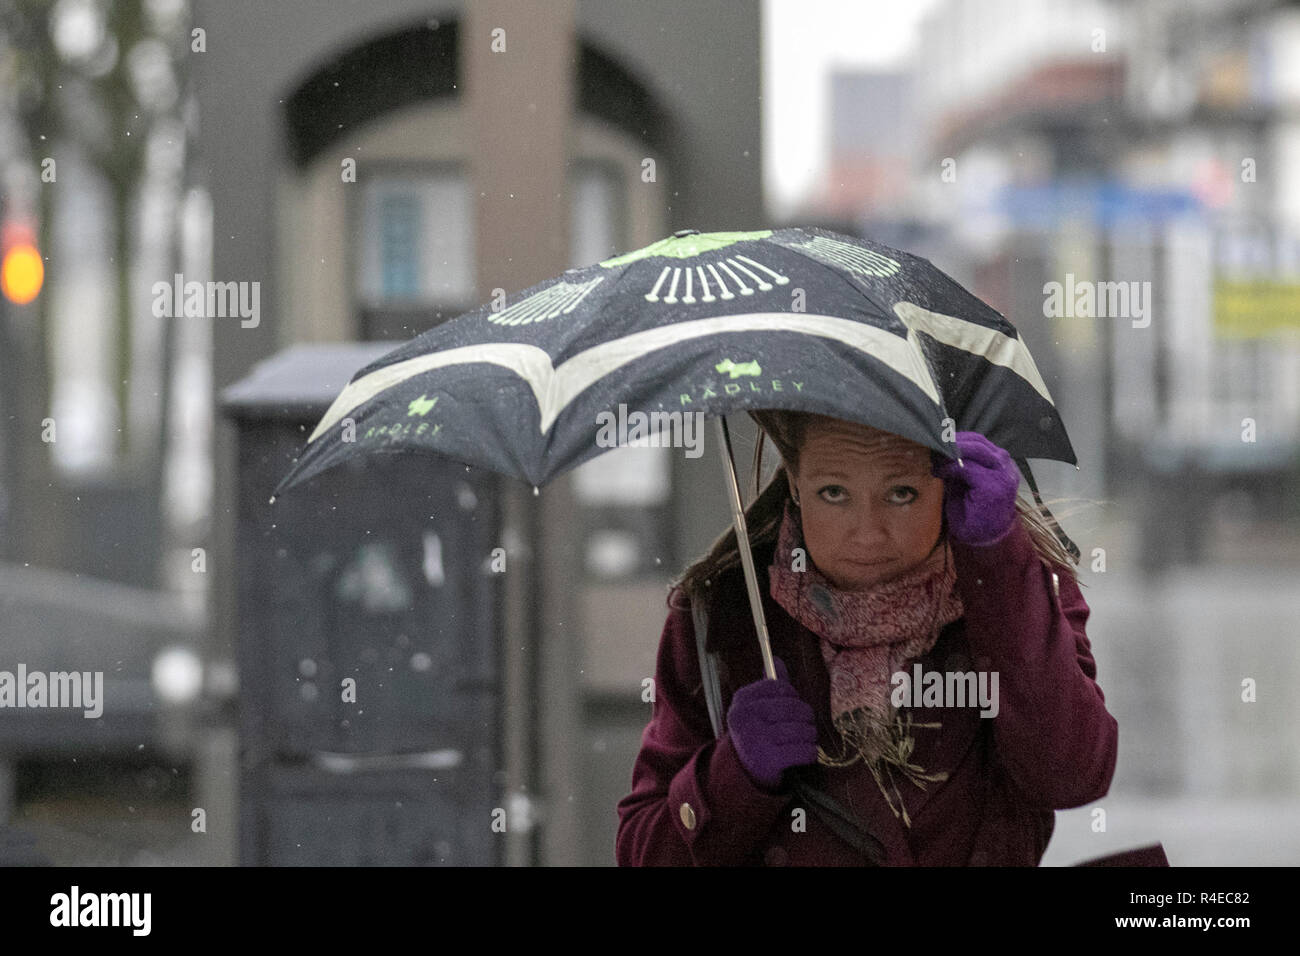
[0,0,1300,865]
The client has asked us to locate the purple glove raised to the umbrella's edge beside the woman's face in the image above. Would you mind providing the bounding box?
[931,432,1021,546]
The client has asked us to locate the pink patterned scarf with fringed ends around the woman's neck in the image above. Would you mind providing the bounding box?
[767,502,963,826]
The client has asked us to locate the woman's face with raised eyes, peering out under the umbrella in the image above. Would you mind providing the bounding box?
[796,421,944,591]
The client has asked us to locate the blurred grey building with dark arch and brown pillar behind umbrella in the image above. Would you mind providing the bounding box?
[198,3,762,864]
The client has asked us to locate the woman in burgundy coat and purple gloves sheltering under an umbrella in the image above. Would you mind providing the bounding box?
[615,411,1118,866]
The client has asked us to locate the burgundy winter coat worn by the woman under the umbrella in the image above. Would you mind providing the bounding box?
[615,522,1118,866]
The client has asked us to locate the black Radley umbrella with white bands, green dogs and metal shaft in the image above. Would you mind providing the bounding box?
[272,229,1079,678]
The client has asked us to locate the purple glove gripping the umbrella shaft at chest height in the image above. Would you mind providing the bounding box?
[727,657,816,790]
